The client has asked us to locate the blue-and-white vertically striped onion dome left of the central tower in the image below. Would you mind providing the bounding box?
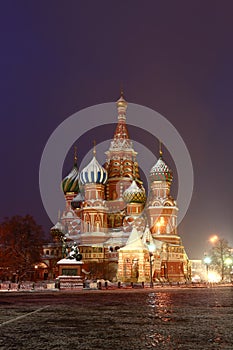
[80,155,108,185]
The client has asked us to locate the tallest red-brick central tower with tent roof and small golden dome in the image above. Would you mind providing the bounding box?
[105,91,142,228]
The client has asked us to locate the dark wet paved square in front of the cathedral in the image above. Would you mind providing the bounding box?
[0,287,233,350]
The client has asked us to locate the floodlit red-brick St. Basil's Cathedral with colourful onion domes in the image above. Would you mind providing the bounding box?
[44,93,191,283]
